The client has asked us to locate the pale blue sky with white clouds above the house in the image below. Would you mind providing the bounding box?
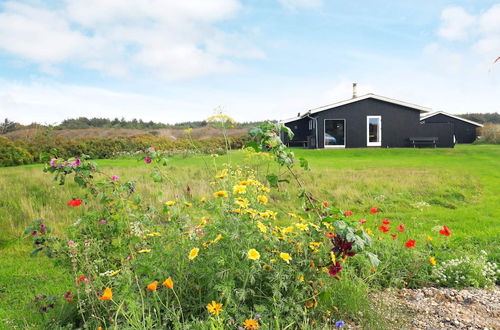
[0,0,500,124]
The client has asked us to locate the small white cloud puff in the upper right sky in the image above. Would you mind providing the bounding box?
[438,7,476,40]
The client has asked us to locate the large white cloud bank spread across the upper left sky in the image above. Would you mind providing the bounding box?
[0,0,264,79]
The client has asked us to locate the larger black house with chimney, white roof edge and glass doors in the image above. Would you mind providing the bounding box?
[282,84,455,149]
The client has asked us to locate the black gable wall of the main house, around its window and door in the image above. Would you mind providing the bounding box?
[312,99,420,148]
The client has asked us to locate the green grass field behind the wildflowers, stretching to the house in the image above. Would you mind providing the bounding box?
[0,145,500,328]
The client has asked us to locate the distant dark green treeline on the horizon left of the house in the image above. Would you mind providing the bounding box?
[0,117,261,134]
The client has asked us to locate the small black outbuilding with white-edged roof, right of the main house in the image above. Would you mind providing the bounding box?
[420,111,483,143]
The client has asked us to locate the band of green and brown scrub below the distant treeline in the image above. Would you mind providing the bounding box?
[0,130,249,167]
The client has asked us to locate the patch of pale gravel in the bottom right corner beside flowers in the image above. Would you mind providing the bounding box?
[374,287,500,330]
